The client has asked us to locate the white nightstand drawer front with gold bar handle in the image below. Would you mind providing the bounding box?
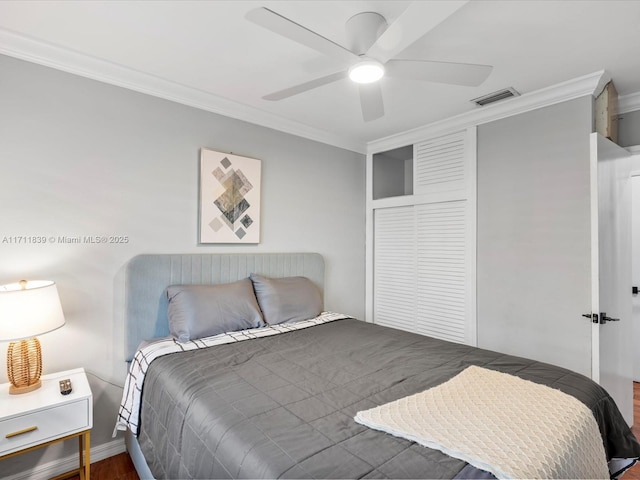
[0,398,91,455]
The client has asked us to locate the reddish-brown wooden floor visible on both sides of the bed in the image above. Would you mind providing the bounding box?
[72,383,640,480]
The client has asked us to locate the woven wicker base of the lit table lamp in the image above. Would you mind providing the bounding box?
[7,337,42,395]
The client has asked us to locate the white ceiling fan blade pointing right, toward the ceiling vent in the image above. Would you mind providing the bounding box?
[385,60,493,87]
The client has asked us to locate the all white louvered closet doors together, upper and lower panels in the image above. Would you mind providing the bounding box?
[373,130,476,345]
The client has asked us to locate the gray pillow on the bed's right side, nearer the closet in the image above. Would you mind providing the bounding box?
[250,273,322,325]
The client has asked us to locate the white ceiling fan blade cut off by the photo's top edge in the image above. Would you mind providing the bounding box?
[367,0,469,63]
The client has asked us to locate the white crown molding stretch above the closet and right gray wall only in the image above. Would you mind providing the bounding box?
[367,70,611,153]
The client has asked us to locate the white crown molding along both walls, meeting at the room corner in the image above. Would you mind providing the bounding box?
[0,25,624,153]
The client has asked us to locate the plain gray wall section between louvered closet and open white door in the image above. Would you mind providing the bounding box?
[477,97,592,375]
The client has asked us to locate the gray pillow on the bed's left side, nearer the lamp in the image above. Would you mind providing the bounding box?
[166,278,264,342]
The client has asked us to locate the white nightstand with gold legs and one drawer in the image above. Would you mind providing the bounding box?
[0,368,93,480]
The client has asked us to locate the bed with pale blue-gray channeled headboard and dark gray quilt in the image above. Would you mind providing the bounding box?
[118,253,640,478]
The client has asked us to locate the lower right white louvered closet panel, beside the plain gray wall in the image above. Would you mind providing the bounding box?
[415,200,467,343]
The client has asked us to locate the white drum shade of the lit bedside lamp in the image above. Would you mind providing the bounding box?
[0,280,64,341]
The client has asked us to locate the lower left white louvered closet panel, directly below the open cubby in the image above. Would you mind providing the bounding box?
[373,206,416,331]
